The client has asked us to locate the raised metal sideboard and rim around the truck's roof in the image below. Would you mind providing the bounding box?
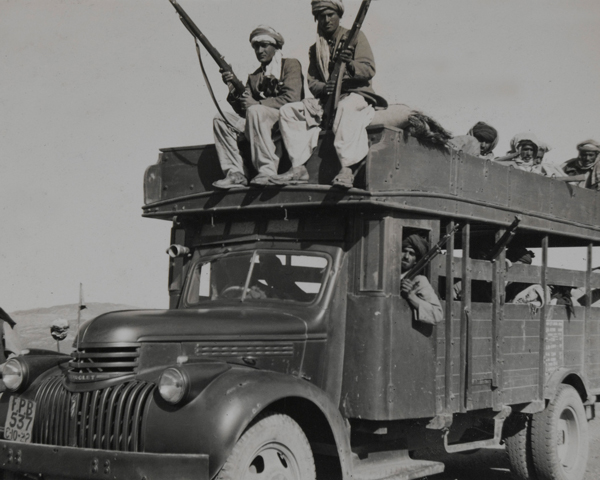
[143,125,600,244]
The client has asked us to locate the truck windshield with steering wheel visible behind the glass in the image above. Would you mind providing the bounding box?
[187,251,329,305]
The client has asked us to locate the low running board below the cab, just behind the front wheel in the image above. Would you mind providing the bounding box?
[352,450,444,480]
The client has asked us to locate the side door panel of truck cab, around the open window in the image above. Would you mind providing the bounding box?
[341,214,439,420]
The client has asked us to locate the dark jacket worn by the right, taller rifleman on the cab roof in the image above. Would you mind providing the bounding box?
[308,27,388,107]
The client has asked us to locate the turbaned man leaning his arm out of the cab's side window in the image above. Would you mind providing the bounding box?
[401,233,444,325]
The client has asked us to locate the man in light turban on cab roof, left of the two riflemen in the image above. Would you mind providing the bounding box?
[213,25,304,189]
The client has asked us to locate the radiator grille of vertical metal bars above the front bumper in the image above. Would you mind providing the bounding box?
[33,376,154,452]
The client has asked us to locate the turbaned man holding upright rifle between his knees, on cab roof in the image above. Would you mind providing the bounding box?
[271,0,387,188]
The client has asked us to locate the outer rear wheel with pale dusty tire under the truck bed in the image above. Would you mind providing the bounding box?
[531,385,589,480]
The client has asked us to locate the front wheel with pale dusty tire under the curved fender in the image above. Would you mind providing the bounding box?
[216,413,316,480]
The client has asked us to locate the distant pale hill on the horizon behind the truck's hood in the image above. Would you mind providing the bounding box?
[10,303,138,353]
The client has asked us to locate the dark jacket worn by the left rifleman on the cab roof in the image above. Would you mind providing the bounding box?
[227,58,304,115]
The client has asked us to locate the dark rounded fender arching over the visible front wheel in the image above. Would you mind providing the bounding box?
[144,364,350,478]
